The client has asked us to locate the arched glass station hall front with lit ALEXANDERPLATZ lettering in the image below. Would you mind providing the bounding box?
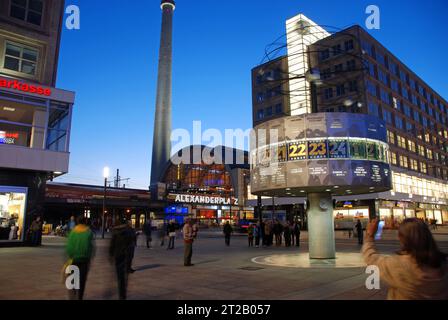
[162,146,254,226]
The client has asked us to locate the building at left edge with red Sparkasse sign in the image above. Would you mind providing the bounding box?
[0,0,75,243]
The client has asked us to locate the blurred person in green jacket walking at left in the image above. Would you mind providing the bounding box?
[66,216,95,300]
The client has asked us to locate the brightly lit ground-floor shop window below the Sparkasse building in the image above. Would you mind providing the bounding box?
[0,186,27,241]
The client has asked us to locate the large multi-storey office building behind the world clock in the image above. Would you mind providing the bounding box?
[252,15,448,227]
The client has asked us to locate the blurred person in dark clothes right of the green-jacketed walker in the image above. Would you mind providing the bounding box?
[109,219,133,300]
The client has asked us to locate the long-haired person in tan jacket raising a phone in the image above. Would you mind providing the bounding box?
[361,218,448,300]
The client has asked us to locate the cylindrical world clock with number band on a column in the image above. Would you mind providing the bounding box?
[251,113,392,259]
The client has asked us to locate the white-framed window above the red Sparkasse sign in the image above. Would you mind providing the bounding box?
[3,42,38,76]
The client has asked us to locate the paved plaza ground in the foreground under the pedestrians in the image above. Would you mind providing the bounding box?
[0,231,448,300]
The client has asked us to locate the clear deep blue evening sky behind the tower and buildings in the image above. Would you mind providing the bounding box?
[57,0,448,188]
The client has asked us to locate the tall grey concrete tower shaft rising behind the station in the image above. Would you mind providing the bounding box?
[151,0,176,188]
